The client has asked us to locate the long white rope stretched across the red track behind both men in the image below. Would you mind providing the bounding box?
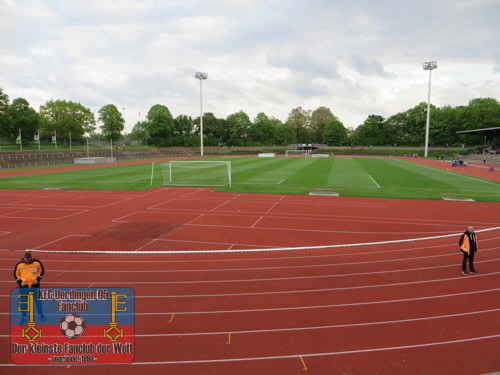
[26,227,500,255]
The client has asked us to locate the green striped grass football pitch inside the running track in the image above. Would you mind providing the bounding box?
[0,158,500,202]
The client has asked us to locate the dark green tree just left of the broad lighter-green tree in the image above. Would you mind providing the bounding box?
[7,98,40,144]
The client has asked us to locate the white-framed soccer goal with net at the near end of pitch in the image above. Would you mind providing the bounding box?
[151,160,232,187]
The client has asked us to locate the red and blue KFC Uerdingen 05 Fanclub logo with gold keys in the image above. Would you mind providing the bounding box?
[10,287,135,366]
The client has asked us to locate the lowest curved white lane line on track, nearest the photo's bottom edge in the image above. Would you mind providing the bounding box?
[0,332,500,367]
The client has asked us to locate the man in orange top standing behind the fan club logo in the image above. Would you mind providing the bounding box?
[14,252,45,324]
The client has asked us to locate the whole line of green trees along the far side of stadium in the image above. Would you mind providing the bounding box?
[0,88,500,147]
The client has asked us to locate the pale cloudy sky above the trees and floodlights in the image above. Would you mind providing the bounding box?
[0,0,500,132]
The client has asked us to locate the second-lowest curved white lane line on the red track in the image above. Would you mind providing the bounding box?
[0,308,500,337]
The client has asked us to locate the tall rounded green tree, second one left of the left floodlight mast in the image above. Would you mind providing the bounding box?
[146,104,174,147]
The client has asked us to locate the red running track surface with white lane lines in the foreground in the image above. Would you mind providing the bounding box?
[0,188,500,374]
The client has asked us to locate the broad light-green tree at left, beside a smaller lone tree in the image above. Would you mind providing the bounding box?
[40,100,95,142]
